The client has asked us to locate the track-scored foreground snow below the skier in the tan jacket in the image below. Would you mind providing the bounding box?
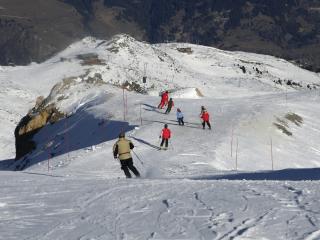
[0,176,320,239]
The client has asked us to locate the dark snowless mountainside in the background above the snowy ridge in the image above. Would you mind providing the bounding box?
[0,0,320,71]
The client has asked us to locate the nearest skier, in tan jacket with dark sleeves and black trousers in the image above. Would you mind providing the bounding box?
[113,132,140,178]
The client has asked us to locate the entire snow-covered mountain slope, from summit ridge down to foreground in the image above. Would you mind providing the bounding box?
[0,35,320,239]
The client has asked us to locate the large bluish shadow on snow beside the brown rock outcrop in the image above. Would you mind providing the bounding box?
[0,111,135,171]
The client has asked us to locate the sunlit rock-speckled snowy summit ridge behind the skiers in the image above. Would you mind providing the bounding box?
[18,35,320,98]
